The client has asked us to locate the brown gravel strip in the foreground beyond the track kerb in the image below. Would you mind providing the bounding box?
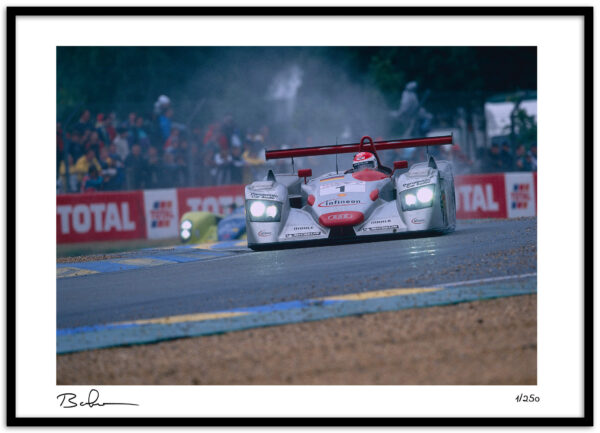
[57,295,537,385]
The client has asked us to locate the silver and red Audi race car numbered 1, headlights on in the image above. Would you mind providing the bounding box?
[245,136,456,250]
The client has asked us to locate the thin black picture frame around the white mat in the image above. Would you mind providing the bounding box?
[6,6,593,427]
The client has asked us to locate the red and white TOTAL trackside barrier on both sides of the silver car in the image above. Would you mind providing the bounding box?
[56,172,537,244]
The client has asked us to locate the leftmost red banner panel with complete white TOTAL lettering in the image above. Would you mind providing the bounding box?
[56,191,146,244]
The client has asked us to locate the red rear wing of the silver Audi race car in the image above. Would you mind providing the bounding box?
[265,135,452,159]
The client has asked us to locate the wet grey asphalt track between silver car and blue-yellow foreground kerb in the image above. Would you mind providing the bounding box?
[57,218,537,328]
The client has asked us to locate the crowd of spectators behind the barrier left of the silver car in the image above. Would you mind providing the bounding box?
[56,95,269,192]
